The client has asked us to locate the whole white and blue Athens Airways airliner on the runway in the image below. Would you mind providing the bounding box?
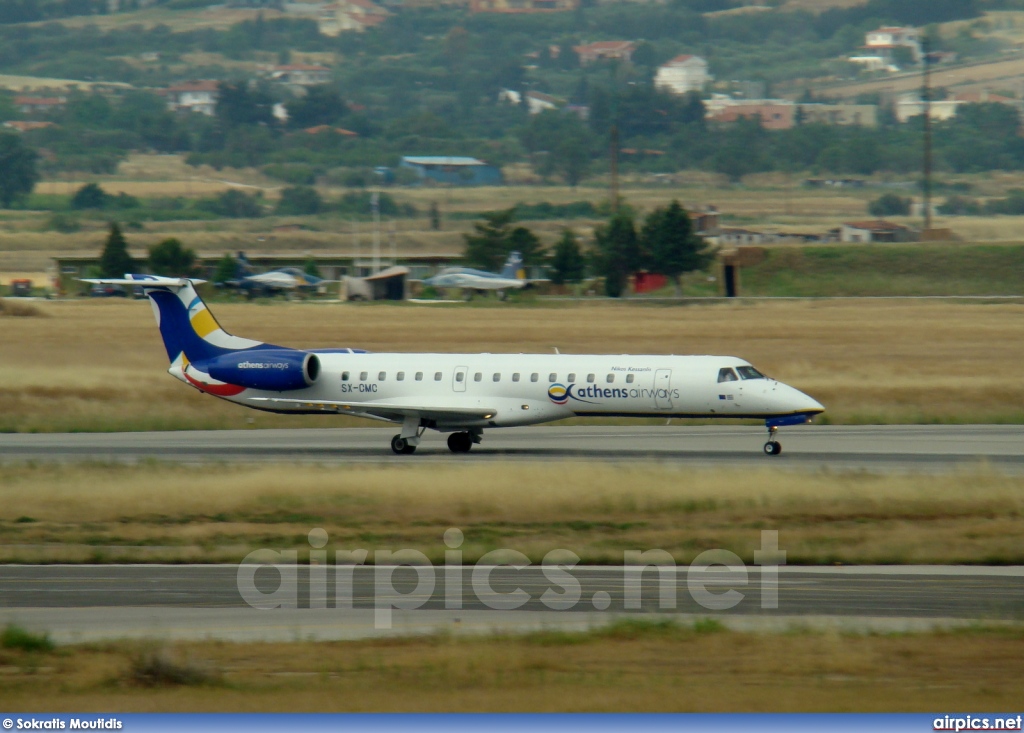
[86,274,824,456]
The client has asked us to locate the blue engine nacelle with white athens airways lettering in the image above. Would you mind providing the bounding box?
[203,349,321,392]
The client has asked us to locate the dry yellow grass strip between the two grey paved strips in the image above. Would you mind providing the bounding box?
[0,463,1024,564]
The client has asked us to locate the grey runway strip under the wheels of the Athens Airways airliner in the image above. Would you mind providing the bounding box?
[0,425,1024,473]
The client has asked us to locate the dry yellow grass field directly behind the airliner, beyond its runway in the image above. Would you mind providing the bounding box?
[0,301,1024,431]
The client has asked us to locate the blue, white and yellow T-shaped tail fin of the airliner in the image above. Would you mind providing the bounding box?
[85,274,275,364]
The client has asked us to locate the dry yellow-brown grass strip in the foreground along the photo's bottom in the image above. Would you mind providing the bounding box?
[0,623,1024,713]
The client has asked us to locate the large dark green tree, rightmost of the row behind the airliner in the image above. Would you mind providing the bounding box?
[640,201,714,295]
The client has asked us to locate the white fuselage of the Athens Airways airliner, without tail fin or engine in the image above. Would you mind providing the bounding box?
[171,351,822,430]
